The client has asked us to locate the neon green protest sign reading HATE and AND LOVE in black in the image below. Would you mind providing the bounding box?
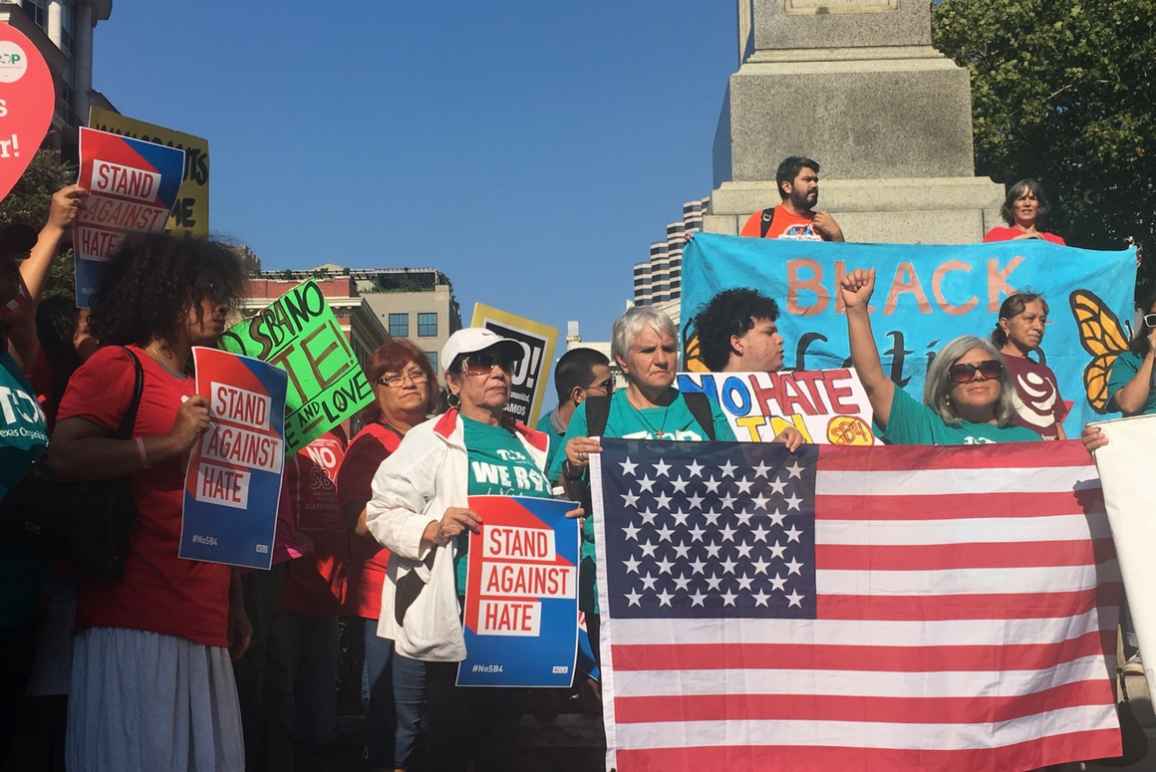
[221,282,373,453]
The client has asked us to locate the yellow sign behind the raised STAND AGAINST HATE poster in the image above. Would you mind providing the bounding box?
[88,107,209,236]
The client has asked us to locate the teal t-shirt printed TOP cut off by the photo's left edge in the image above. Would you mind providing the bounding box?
[0,351,49,630]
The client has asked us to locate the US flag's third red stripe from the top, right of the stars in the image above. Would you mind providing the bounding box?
[815,539,1116,571]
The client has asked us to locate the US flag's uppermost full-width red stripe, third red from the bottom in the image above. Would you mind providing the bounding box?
[610,630,1116,673]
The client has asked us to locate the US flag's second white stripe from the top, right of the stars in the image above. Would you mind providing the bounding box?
[815,512,1112,545]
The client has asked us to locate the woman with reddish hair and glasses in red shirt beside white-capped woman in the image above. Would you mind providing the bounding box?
[338,339,438,770]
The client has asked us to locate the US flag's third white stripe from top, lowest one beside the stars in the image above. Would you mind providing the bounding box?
[815,561,1120,595]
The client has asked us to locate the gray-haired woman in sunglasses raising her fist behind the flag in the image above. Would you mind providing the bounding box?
[840,269,1040,445]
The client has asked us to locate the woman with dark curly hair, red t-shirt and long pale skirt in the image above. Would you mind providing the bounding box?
[50,235,250,772]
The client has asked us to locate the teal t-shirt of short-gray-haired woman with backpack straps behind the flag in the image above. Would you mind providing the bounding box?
[548,389,735,614]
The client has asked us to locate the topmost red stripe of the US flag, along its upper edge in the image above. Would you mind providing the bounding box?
[818,440,1095,473]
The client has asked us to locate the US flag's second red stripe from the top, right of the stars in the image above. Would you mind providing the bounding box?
[815,489,1104,520]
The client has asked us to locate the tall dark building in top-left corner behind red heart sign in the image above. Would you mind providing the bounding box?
[0,0,114,134]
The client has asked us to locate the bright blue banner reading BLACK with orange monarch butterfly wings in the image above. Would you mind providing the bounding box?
[681,233,1136,437]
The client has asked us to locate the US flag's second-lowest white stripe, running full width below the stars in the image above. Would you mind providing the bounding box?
[602,655,1110,698]
